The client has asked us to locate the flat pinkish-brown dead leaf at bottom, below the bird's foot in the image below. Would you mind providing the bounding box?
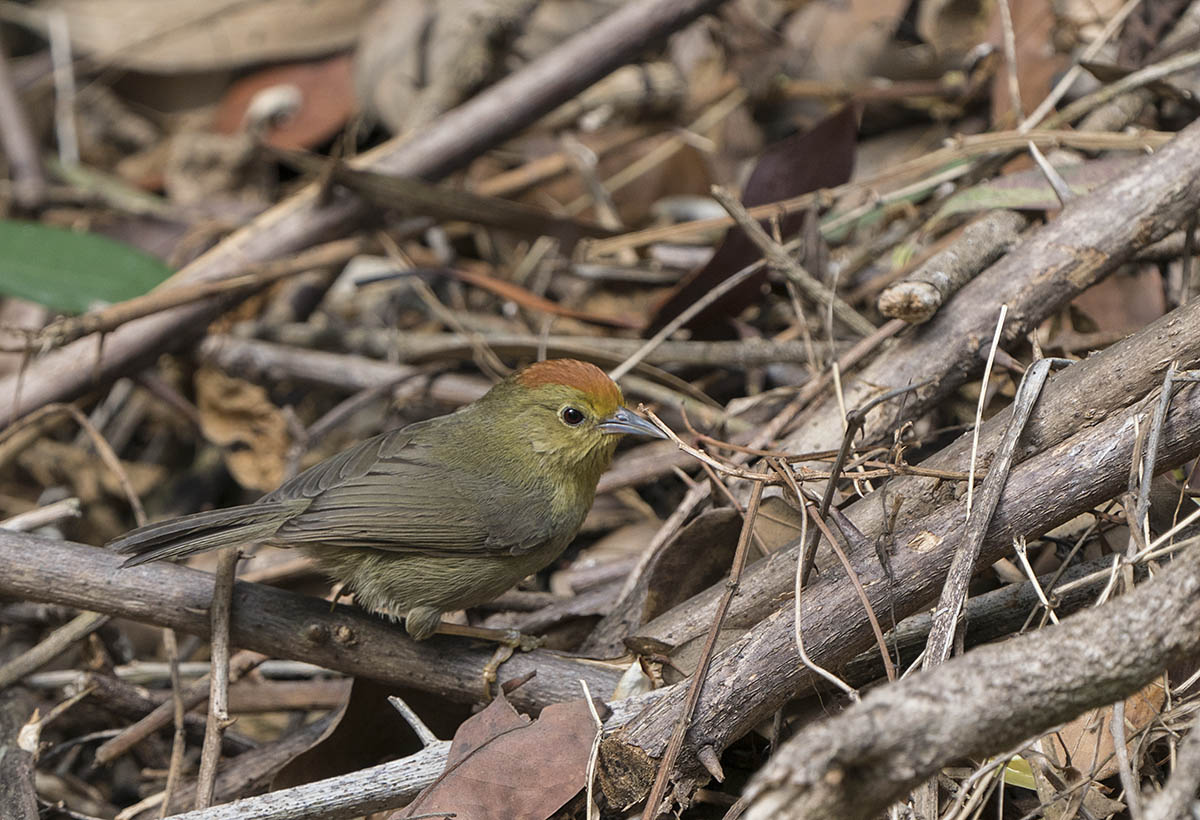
[389,694,604,820]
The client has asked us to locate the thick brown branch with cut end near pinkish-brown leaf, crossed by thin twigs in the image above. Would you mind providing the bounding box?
[602,365,1200,804]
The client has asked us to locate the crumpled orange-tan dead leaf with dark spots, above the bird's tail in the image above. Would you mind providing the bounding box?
[196,367,292,492]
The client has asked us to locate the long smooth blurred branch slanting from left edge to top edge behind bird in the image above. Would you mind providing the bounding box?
[0,0,721,418]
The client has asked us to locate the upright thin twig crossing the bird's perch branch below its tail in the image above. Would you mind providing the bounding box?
[196,546,241,809]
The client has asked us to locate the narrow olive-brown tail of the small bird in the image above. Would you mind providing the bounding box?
[108,498,311,567]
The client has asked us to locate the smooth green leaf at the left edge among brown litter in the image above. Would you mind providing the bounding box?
[0,220,172,313]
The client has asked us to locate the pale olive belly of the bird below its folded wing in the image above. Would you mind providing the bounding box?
[305,544,565,616]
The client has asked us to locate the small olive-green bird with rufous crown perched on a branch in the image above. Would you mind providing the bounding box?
[109,359,665,640]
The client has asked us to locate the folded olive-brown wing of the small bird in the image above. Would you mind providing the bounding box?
[264,424,551,556]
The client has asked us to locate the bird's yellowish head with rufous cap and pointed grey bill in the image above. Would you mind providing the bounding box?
[488,359,665,478]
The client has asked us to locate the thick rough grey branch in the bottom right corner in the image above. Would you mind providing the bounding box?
[745,547,1200,820]
